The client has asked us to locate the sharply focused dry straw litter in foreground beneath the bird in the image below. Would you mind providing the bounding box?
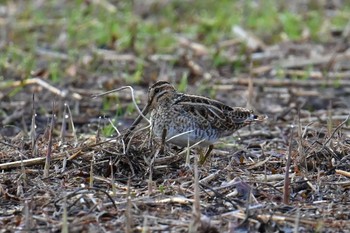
[0,108,350,232]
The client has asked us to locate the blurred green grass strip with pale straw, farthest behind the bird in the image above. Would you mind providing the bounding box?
[0,0,350,83]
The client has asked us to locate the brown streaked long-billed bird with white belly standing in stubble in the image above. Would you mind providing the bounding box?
[125,81,267,161]
